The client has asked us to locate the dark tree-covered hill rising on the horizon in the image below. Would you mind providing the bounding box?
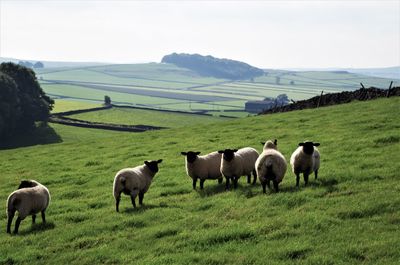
[161,53,264,80]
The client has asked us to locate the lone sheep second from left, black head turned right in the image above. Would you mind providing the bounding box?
[113,159,162,212]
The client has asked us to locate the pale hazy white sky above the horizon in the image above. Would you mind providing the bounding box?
[0,0,400,68]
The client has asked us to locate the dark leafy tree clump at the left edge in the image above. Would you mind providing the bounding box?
[0,63,54,140]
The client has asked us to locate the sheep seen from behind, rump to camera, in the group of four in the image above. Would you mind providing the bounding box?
[255,140,287,193]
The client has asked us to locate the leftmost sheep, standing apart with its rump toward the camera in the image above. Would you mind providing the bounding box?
[7,180,50,234]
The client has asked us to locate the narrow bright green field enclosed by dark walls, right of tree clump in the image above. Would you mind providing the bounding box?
[68,108,227,128]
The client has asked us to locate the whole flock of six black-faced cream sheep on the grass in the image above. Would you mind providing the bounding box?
[7,140,320,233]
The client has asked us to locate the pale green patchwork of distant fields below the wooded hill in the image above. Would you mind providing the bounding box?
[36,63,400,112]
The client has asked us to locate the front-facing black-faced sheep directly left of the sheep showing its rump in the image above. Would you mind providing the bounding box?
[218,147,258,190]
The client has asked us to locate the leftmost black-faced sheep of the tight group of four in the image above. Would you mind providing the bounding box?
[181,151,223,189]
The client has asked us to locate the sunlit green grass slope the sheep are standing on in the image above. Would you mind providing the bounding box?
[0,98,400,265]
